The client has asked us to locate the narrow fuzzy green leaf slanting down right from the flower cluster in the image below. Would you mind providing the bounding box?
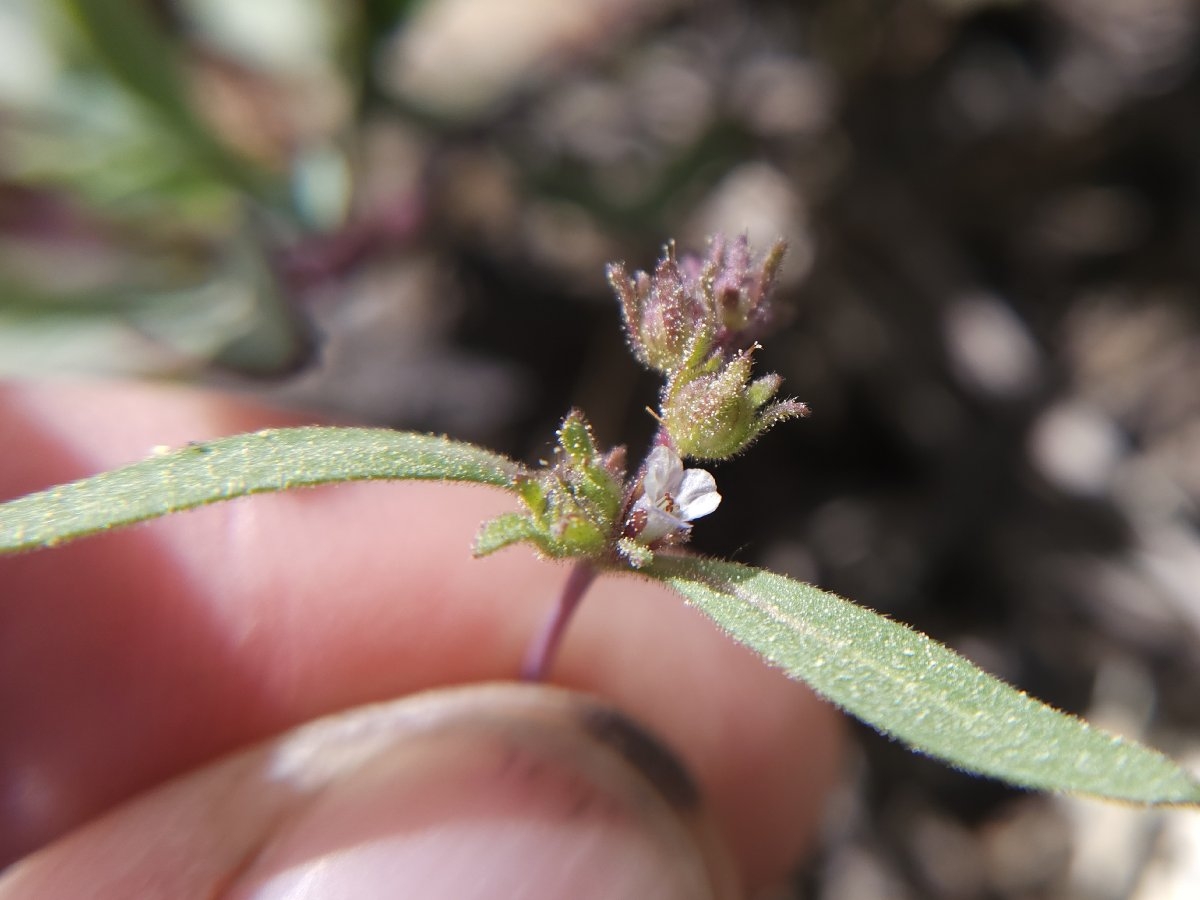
[646,556,1200,804]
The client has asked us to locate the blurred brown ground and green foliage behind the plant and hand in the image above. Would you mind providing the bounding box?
[0,0,1200,900]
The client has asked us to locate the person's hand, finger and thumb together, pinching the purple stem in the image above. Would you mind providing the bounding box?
[0,385,839,900]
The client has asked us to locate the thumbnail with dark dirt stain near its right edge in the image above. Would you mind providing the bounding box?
[226,684,737,900]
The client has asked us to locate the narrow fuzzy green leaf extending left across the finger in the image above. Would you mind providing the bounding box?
[0,427,521,553]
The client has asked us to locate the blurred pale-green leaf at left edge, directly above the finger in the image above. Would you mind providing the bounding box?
[0,229,313,378]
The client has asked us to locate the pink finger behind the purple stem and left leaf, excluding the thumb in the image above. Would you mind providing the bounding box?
[0,383,841,896]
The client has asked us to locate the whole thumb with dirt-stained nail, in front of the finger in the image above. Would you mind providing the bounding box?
[0,684,739,900]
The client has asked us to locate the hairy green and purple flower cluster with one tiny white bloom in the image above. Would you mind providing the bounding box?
[475,236,808,569]
